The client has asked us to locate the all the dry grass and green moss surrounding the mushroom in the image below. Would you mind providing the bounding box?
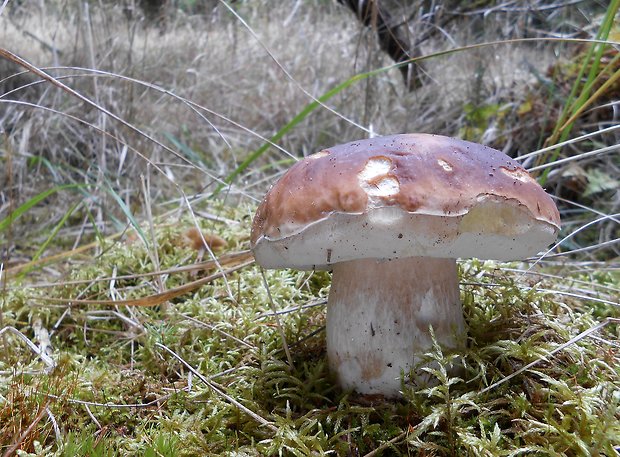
[0,0,620,457]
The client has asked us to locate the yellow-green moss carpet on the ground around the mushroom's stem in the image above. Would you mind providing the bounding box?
[0,205,620,457]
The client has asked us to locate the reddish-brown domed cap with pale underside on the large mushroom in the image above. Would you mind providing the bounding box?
[251,134,560,269]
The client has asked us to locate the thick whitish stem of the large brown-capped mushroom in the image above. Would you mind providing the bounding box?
[327,257,465,397]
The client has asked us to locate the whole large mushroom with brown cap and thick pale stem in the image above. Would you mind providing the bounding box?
[251,134,560,397]
